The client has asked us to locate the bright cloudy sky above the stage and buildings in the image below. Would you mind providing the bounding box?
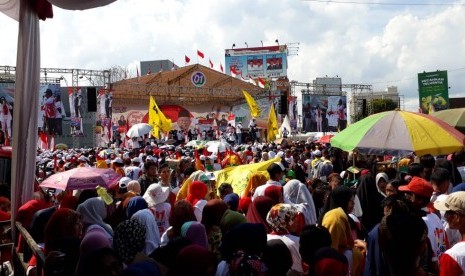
[0,0,465,111]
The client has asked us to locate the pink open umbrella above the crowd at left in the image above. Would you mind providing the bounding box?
[39,167,121,191]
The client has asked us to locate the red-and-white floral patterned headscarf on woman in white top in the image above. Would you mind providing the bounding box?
[266,203,298,235]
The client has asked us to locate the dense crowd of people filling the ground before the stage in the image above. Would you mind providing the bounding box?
[0,140,465,276]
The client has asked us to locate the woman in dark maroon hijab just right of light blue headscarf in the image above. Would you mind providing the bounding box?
[161,200,197,246]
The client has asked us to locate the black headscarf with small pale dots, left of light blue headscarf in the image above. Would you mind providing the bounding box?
[113,219,146,265]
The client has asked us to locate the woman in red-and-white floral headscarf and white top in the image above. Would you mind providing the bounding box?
[266,203,303,273]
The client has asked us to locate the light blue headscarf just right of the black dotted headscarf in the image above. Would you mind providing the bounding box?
[131,209,160,255]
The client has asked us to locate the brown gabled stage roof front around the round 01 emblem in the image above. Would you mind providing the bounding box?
[112,64,265,106]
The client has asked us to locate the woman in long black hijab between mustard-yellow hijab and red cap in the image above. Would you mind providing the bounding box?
[357,174,387,231]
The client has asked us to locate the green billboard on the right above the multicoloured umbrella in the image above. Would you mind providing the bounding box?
[418,71,449,114]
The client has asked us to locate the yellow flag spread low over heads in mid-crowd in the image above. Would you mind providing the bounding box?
[215,157,281,195]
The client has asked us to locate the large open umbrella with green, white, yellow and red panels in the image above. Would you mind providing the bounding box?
[331,110,465,156]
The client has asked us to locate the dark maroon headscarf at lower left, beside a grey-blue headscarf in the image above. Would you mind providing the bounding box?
[44,208,82,254]
